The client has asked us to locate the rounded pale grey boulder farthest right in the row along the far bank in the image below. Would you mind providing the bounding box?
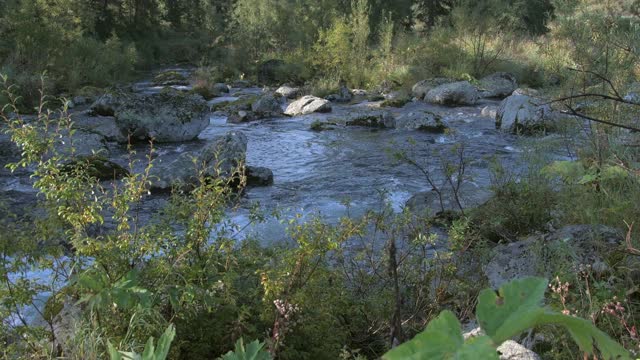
[496,95,554,134]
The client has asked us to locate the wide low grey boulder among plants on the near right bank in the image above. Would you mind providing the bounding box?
[484,225,624,289]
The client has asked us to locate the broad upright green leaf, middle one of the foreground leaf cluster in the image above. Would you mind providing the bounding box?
[476,277,547,344]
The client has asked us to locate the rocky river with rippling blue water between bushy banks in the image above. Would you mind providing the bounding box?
[0,69,580,242]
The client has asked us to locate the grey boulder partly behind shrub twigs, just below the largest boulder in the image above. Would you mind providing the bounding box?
[150,132,247,191]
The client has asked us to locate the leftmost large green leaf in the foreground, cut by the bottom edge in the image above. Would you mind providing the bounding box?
[383,311,498,360]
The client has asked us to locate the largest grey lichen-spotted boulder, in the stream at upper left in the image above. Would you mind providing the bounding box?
[91,89,209,142]
